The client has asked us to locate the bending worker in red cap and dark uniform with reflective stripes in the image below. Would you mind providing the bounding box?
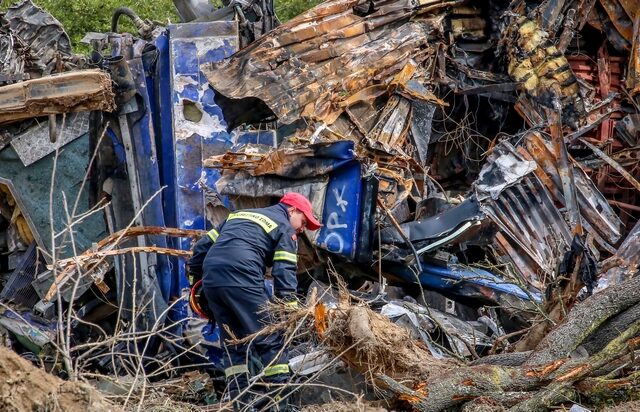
[188,192,321,410]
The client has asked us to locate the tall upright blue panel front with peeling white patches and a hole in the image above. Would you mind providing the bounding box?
[164,22,238,296]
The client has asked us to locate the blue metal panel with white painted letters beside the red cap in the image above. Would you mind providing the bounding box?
[315,160,362,259]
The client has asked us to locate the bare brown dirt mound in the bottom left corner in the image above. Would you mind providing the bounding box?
[0,347,121,412]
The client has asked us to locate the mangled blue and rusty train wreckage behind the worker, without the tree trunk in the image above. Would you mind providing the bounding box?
[0,0,640,406]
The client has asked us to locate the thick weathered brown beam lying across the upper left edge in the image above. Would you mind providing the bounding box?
[0,70,114,125]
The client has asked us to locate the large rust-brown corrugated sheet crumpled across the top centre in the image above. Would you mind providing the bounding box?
[202,0,448,124]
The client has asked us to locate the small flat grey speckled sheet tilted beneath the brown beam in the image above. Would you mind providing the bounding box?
[11,112,89,166]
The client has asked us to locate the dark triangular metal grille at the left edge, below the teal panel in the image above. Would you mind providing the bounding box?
[0,242,45,308]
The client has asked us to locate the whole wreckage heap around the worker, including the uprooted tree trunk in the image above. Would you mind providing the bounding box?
[0,0,640,410]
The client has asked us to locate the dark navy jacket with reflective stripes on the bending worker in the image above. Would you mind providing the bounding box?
[187,203,298,297]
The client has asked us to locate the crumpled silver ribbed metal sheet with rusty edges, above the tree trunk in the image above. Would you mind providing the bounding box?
[474,132,622,289]
